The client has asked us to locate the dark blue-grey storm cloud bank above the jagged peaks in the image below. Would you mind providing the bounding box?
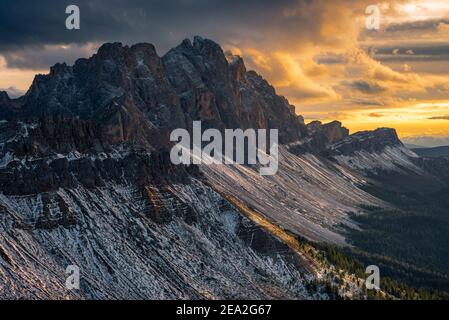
[0,0,309,68]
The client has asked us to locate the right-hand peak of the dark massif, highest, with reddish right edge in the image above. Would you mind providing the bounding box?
[163,37,305,143]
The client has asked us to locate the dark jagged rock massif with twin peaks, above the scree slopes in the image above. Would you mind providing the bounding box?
[5,37,306,158]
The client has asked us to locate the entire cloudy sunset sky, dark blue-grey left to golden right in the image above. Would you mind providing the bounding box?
[0,0,449,144]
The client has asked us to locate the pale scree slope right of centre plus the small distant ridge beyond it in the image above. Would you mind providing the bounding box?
[202,128,439,244]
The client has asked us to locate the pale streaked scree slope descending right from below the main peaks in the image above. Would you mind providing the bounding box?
[201,147,386,244]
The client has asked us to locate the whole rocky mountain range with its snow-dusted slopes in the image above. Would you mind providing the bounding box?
[0,37,449,299]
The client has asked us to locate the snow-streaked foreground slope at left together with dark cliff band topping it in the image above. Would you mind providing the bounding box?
[0,119,317,299]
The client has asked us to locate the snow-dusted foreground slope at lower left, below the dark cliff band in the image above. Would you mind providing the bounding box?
[0,172,313,299]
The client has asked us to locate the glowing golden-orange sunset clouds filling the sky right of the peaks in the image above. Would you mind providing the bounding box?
[0,0,449,136]
